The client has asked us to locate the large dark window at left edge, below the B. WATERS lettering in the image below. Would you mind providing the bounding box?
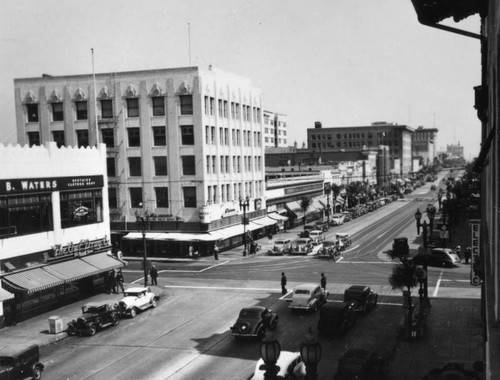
[0,194,54,236]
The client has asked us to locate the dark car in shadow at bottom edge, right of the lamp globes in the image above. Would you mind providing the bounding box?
[333,348,385,380]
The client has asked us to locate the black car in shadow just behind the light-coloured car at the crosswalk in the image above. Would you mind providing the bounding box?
[318,302,357,336]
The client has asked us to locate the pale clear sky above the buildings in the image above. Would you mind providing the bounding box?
[0,0,481,160]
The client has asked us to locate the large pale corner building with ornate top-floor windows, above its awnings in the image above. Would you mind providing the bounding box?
[14,66,266,228]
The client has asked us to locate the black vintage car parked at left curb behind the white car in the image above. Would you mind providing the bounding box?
[67,301,120,336]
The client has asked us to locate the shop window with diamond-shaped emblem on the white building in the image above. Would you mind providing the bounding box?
[60,190,102,228]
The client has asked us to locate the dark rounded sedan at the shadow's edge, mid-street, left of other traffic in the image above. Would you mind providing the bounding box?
[230,306,278,338]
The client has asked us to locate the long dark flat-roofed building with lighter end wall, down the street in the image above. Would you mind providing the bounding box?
[307,121,414,176]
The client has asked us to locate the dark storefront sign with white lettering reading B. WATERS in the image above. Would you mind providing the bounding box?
[0,175,104,195]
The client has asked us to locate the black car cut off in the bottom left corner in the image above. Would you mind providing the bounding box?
[0,344,44,380]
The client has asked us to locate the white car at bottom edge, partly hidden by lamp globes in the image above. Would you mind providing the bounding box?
[252,351,307,380]
